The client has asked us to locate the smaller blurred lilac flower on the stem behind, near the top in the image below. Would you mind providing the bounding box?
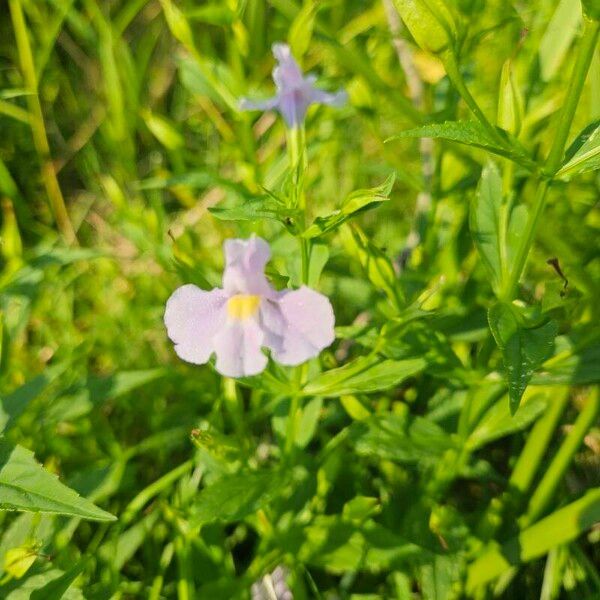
[240,43,347,128]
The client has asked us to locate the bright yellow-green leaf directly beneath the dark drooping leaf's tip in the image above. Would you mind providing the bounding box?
[467,394,548,450]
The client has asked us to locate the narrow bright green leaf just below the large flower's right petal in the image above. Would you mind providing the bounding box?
[303,356,427,398]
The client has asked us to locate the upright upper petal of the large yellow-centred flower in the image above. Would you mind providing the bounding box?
[223,237,274,297]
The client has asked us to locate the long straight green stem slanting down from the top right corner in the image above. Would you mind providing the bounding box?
[504,22,600,301]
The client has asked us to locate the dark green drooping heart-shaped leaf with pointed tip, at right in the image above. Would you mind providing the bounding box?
[488,302,558,414]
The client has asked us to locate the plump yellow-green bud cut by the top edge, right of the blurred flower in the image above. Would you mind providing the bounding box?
[394,0,456,52]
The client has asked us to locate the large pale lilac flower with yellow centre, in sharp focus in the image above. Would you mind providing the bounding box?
[165,237,335,377]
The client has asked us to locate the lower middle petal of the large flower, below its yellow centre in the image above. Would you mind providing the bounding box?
[215,319,268,377]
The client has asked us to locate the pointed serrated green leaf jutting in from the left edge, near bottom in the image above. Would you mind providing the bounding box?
[0,440,116,521]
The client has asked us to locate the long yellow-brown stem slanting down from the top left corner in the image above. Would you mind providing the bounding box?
[9,0,77,243]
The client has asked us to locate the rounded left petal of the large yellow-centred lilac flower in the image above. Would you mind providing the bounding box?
[164,285,227,365]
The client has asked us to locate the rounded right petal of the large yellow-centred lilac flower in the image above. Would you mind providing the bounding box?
[271,286,335,365]
